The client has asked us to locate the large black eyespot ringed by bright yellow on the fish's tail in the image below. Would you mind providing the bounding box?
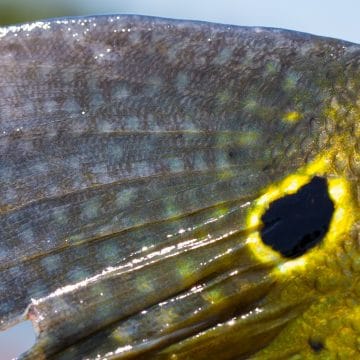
[261,176,334,258]
